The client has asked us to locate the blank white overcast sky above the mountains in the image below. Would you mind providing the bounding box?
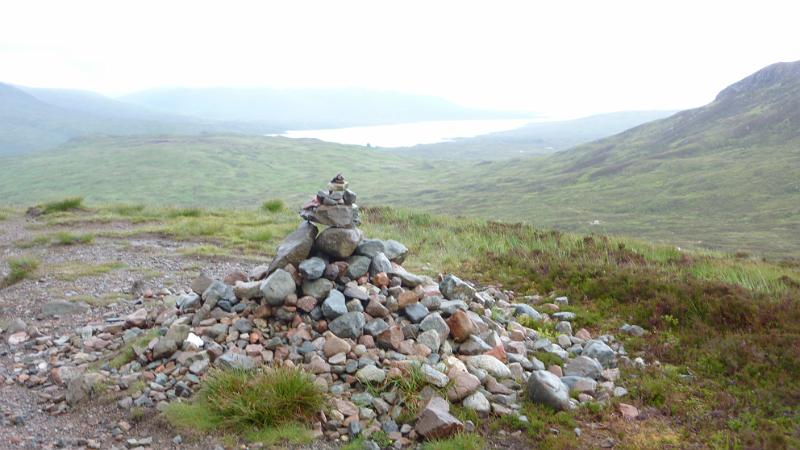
[0,0,800,115]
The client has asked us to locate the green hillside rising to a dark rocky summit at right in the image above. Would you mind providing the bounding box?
[432,61,800,256]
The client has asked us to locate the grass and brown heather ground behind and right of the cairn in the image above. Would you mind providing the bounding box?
[9,202,800,448]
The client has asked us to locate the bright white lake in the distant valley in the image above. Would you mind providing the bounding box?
[280,119,541,147]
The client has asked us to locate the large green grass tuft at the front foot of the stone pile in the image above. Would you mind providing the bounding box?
[164,368,327,443]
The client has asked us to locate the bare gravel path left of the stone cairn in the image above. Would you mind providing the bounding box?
[0,217,254,449]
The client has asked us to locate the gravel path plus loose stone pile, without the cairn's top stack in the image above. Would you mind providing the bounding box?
[0,200,644,448]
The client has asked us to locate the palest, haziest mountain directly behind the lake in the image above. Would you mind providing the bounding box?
[120,87,530,129]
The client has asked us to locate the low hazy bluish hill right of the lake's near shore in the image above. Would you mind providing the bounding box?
[387,111,675,160]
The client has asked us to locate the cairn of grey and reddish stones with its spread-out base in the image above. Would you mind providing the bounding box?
[1,177,645,447]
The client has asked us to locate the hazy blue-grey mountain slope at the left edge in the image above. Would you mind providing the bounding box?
[0,83,279,155]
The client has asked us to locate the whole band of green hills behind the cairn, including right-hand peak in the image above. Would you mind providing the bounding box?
[0,63,800,257]
